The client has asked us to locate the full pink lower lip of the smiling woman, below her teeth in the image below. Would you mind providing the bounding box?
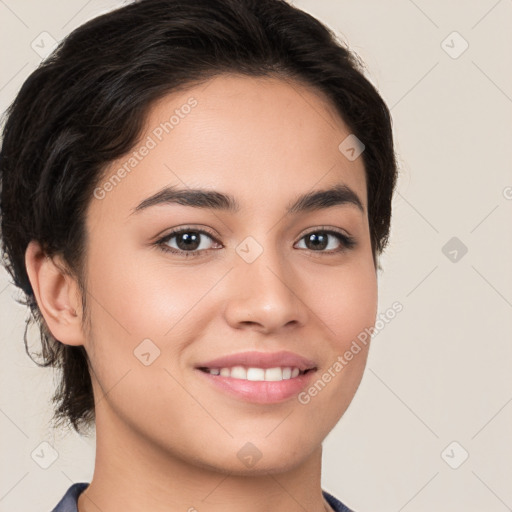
[196,369,315,404]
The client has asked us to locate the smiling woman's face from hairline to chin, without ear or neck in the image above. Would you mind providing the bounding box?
[84,75,377,473]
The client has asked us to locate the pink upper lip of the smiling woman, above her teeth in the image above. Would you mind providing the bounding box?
[196,351,316,371]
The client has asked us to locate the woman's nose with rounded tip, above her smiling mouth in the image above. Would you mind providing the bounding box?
[224,242,310,334]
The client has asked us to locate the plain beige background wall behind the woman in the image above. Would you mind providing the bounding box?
[0,0,512,512]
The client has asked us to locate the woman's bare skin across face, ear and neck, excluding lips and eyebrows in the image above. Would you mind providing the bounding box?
[26,75,377,512]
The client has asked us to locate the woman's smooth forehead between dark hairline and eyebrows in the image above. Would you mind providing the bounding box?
[92,75,367,220]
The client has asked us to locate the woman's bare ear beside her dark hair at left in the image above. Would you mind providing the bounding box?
[25,241,85,345]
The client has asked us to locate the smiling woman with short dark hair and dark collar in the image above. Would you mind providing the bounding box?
[0,0,397,512]
